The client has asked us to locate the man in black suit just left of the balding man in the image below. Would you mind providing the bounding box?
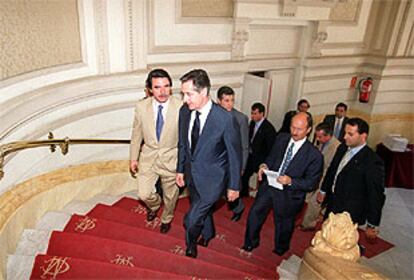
[239,103,276,205]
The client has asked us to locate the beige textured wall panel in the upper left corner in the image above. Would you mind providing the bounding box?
[0,0,82,80]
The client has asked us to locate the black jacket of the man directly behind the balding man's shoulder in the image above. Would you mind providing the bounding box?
[248,119,276,171]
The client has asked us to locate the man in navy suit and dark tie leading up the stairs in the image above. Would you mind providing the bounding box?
[176,69,241,258]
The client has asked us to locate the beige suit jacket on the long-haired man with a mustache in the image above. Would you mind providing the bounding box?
[130,96,183,173]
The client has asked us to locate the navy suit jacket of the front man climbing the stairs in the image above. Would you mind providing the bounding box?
[177,103,241,202]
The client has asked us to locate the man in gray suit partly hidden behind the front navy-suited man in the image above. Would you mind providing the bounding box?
[217,86,249,221]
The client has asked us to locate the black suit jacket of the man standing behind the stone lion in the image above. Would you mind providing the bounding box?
[321,144,385,226]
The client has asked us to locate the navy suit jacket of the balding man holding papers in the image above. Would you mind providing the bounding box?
[265,133,323,201]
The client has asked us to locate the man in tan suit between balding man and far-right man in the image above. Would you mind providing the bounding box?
[300,123,341,231]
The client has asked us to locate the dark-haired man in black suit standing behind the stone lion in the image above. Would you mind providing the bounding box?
[317,118,385,240]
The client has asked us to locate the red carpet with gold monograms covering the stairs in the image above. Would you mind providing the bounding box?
[31,198,393,279]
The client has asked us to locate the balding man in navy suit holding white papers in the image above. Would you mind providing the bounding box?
[242,113,323,256]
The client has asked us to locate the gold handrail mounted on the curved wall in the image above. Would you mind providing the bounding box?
[0,132,130,180]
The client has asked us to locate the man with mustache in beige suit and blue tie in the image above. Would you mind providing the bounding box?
[130,69,183,233]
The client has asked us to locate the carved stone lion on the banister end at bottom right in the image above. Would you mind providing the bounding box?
[298,212,387,280]
